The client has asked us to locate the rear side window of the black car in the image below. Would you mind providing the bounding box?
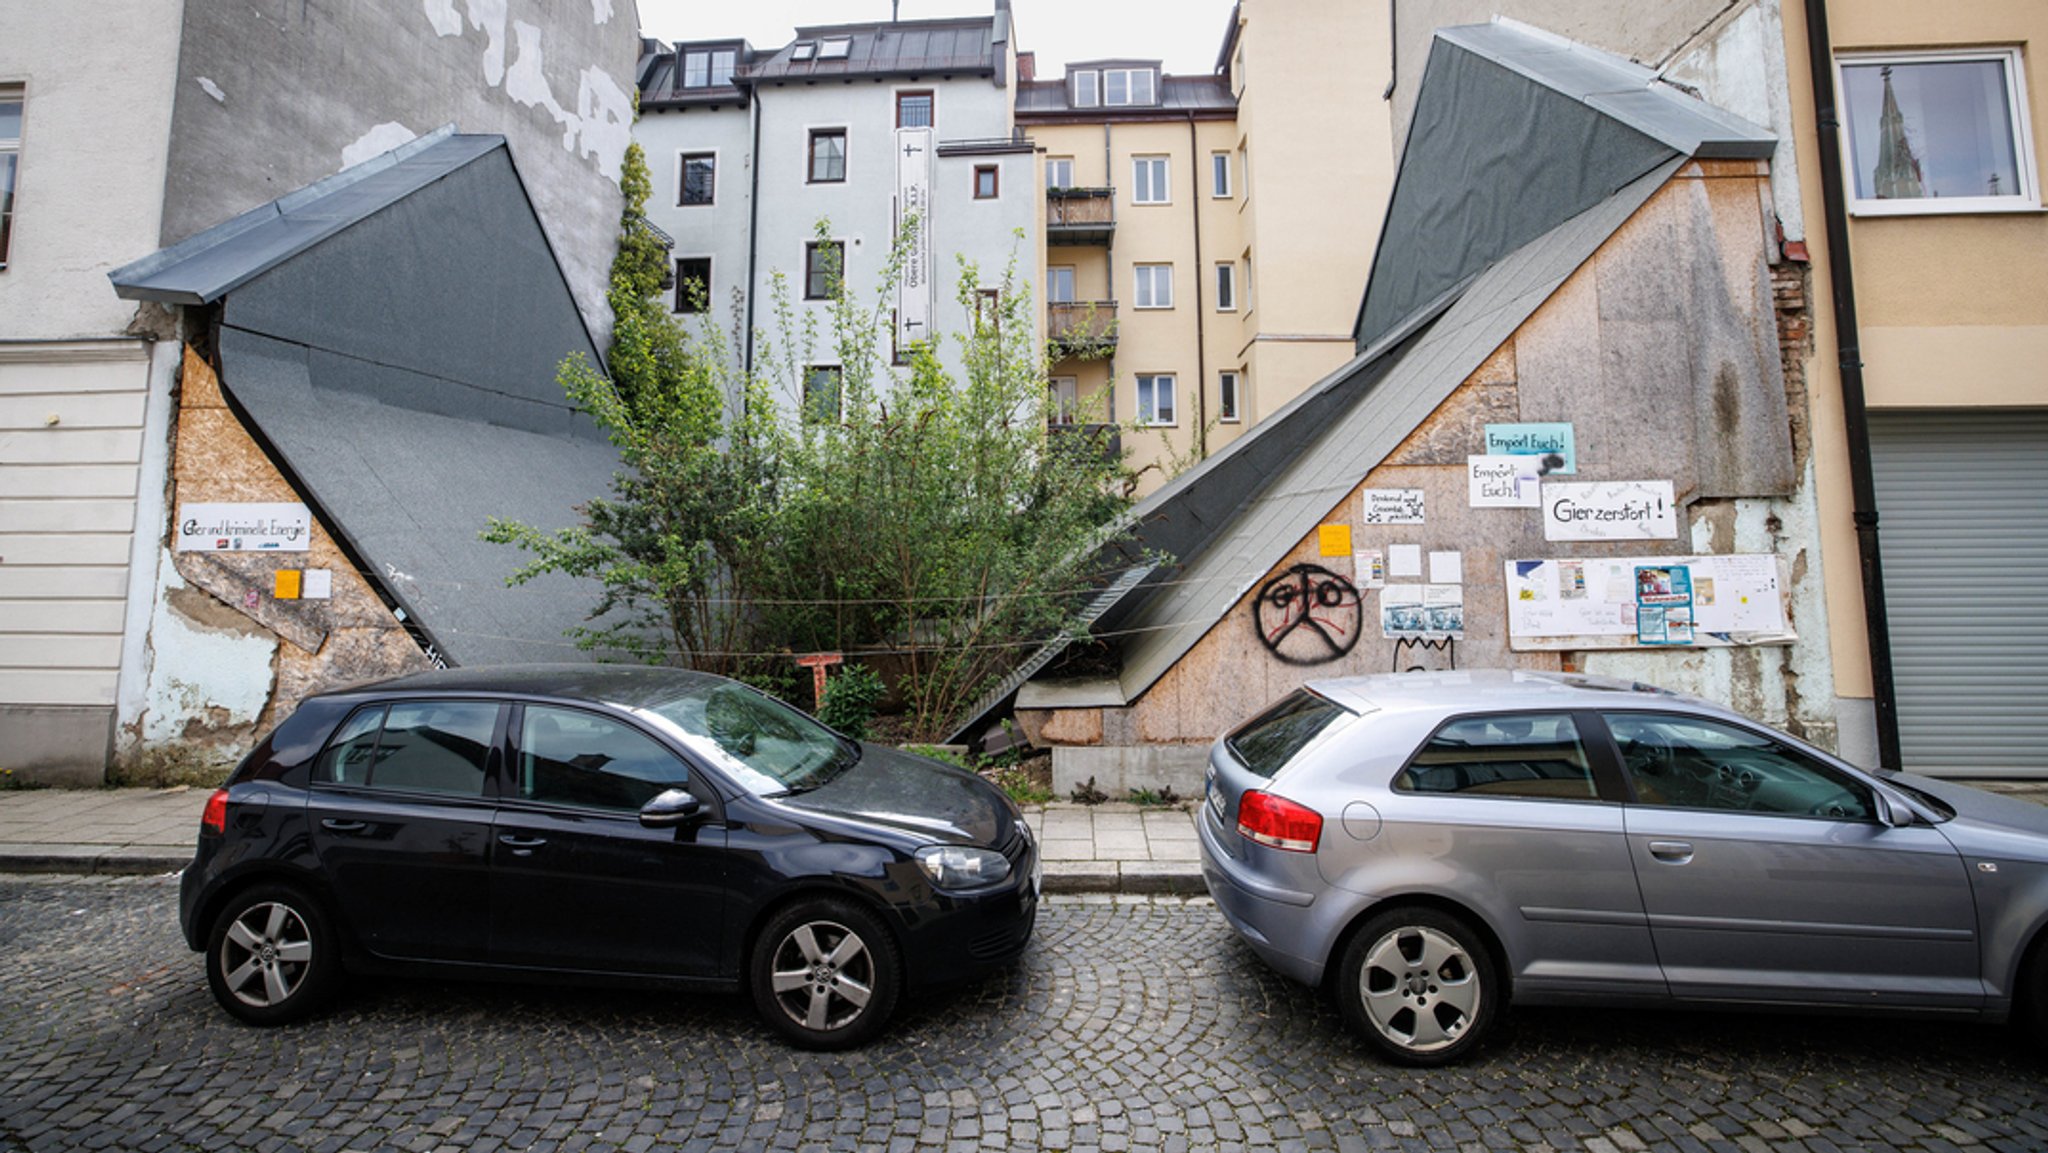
[313,700,498,797]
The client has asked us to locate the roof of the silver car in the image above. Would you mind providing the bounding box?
[1309,668,1726,715]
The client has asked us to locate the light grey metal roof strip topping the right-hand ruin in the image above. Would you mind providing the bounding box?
[1436,18,1778,158]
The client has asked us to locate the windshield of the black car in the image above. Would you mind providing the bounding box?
[641,682,860,797]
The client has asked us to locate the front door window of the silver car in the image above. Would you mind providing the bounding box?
[1606,713,1876,821]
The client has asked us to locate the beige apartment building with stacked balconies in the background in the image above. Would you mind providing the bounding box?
[1018,0,1395,492]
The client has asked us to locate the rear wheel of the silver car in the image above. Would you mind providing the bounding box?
[1337,907,1499,1065]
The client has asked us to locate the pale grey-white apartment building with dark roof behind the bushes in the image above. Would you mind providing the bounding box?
[635,0,1038,416]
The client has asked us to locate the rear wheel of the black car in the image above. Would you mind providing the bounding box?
[207,883,342,1024]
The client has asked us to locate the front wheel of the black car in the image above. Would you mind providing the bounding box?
[752,897,903,1049]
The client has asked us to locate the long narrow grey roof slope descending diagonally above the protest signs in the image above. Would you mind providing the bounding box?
[1120,160,1683,700]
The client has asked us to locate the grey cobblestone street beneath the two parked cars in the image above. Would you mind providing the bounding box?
[0,879,2048,1153]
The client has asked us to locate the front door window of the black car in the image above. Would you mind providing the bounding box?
[518,704,690,813]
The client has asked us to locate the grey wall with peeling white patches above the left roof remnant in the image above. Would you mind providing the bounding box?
[160,0,639,348]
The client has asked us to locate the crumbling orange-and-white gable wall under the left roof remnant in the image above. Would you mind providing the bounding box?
[121,348,428,762]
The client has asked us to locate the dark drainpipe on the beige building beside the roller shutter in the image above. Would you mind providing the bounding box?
[1806,0,1901,768]
